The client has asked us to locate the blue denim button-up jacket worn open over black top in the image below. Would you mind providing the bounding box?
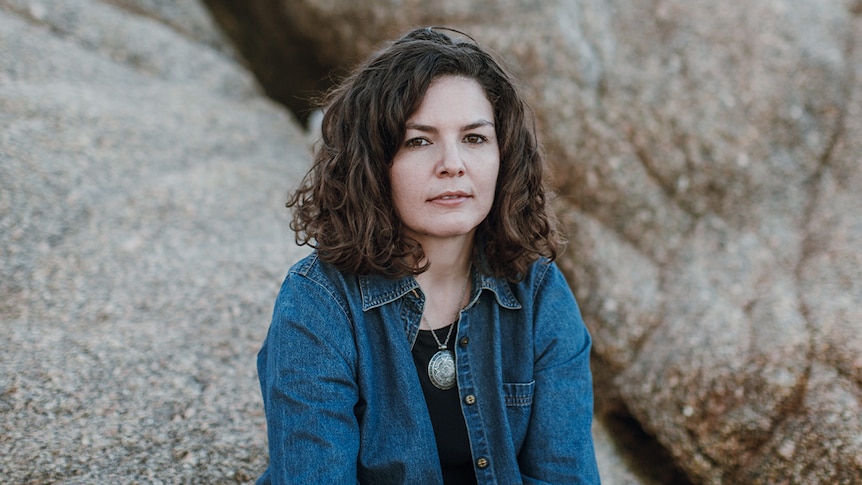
[257,253,599,485]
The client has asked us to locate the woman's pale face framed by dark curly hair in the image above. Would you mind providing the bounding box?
[389,76,500,245]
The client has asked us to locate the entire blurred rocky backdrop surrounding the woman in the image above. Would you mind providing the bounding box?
[0,0,862,484]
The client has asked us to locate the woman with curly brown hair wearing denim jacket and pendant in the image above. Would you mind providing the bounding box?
[258,28,599,484]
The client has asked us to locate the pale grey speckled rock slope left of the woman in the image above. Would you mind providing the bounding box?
[0,0,309,483]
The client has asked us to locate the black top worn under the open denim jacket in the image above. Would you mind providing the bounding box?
[413,323,476,485]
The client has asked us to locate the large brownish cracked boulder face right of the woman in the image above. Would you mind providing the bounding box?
[204,0,862,484]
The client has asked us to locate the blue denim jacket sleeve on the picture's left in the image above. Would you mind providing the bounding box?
[257,274,359,484]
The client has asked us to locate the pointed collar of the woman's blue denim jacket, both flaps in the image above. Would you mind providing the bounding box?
[359,269,521,312]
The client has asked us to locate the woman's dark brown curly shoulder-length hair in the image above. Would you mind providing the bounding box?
[287,28,562,281]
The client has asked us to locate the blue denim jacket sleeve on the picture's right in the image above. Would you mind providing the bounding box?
[519,264,600,484]
